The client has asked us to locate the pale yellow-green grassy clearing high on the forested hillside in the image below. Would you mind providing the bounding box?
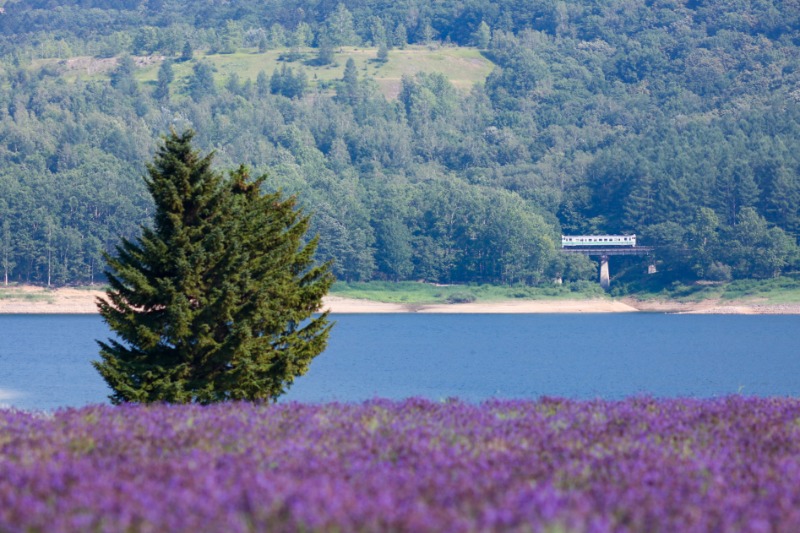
[43,46,494,99]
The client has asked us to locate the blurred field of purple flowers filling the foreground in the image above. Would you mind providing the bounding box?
[0,396,800,533]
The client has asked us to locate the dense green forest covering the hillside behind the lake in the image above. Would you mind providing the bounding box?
[0,0,800,290]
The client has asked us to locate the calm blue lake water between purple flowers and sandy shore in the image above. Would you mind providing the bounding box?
[0,313,800,410]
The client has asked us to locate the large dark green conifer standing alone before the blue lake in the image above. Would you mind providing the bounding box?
[94,131,333,404]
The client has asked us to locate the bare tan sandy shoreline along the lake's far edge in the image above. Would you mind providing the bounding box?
[0,285,800,315]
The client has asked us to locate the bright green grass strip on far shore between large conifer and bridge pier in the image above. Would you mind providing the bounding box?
[331,281,606,304]
